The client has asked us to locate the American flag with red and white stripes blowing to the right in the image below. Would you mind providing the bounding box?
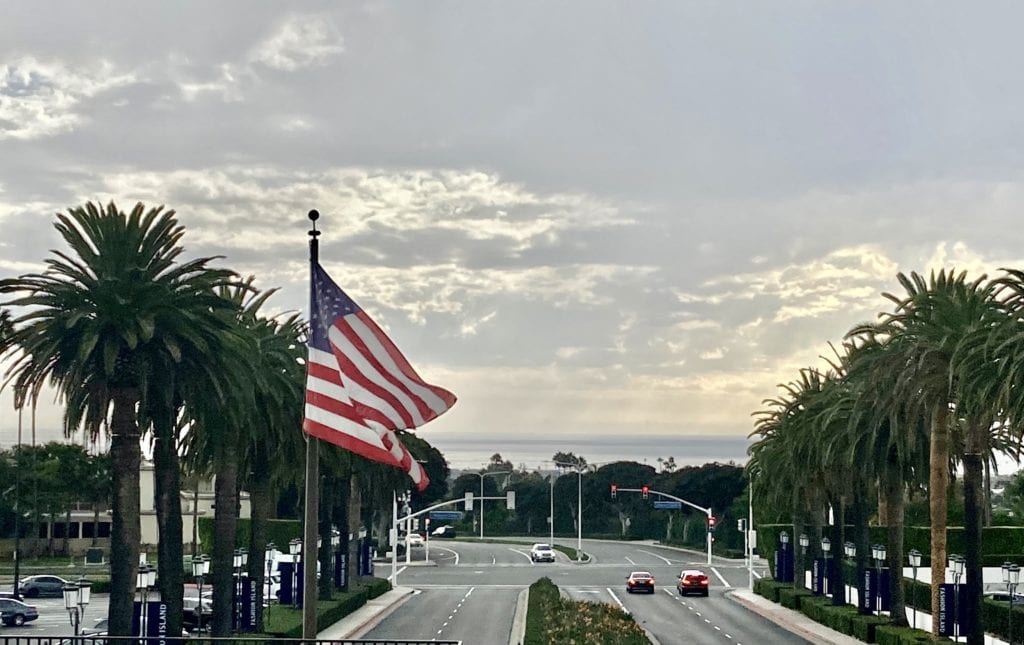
[302,264,456,490]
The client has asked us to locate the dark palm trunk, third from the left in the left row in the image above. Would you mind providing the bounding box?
[210,452,239,637]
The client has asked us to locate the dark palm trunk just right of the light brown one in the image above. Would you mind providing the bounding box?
[964,421,986,645]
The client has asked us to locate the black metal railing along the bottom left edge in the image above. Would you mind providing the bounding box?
[0,634,462,645]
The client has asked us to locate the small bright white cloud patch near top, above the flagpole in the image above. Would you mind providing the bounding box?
[252,15,345,72]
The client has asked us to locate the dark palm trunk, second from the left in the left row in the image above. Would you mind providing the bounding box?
[153,421,185,634]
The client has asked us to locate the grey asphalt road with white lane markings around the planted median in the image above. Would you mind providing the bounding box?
[362,539,807,645]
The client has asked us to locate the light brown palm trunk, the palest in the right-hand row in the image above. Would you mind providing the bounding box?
[928,401,949,636]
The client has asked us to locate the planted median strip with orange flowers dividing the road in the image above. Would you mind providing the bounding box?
[523,577,650,645]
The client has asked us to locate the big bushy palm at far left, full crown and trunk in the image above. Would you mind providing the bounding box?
[0,202,232,636]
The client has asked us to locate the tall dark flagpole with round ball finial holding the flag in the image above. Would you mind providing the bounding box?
[302,210,327,640]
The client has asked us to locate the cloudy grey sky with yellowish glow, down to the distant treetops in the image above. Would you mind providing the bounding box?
[0,0,1024,473]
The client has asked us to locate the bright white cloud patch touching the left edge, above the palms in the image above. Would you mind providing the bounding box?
[0,56,137,140]
